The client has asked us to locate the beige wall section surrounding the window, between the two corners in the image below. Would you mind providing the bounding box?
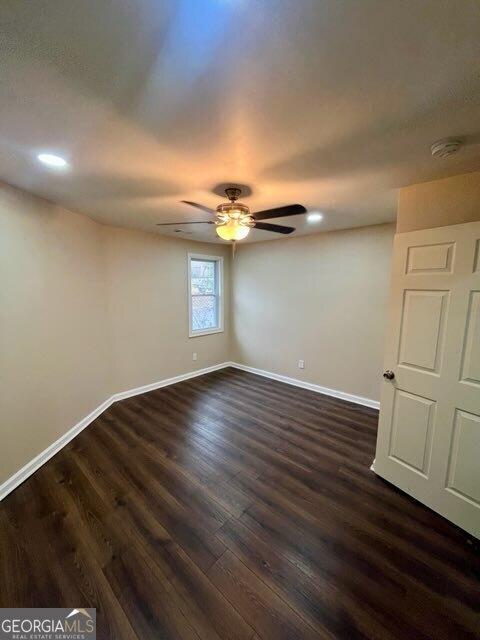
[104,227,231,391]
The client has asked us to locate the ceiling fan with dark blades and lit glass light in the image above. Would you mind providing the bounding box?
[157,187,307,242]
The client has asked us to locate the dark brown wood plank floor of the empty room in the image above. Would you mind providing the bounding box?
[0,369,480,640]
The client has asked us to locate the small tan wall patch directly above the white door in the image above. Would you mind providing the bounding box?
[397,171,480,233]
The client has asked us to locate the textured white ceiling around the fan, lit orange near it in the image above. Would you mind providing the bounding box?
[0,0,480,240]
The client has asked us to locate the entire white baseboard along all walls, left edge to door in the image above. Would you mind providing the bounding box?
[0,362,380,500]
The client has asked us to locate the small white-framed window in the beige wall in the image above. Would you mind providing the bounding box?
[188,253,223,337]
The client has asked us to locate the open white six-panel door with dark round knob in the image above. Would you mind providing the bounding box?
[374,222,480,537]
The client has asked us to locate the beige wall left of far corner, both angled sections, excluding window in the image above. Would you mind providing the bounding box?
[0,186,230,484]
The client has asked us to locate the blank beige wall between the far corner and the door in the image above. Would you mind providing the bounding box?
[232,225,394,400]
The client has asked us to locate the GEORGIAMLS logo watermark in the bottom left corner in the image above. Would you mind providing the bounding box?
[0,609,97,640]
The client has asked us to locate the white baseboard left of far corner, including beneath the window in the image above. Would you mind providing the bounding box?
[0,362,231,500]
